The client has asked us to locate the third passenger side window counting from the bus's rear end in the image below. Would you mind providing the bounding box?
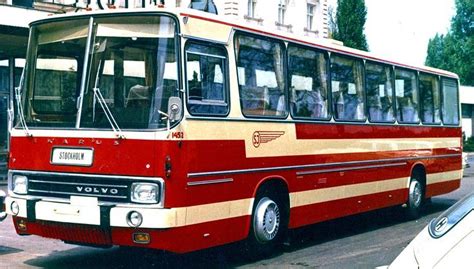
[395,69,419,123]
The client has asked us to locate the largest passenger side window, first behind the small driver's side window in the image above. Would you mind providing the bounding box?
[235,34,288,118]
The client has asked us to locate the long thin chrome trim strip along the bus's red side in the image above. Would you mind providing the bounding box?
[188,154,462,178]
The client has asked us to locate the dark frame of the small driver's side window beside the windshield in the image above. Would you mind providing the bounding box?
[183,39,231,117]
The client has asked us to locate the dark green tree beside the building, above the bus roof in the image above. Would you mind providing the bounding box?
[330,0,369,51]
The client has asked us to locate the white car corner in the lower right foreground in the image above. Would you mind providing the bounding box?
[386,192,474,269]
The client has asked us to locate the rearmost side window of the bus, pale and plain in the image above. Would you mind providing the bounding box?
[441,78,459,125]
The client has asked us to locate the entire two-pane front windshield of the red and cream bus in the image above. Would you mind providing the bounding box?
[23,16,181,129]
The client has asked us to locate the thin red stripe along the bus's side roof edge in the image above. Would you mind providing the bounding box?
[180,13,458,79]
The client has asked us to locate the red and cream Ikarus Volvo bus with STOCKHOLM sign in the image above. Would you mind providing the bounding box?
[6,8,462,253]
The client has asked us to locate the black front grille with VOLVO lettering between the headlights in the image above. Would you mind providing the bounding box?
[28,174,132,202]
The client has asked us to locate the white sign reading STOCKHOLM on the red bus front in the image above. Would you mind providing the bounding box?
[51,148,94,166]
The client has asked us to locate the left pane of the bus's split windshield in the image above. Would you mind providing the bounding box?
[25,20,88,127]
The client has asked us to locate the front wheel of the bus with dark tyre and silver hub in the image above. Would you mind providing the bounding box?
[247,187,288,259]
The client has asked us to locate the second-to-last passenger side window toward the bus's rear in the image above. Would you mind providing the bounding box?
[419,74,441,124]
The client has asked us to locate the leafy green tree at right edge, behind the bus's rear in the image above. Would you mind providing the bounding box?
[425,0,474,86]
